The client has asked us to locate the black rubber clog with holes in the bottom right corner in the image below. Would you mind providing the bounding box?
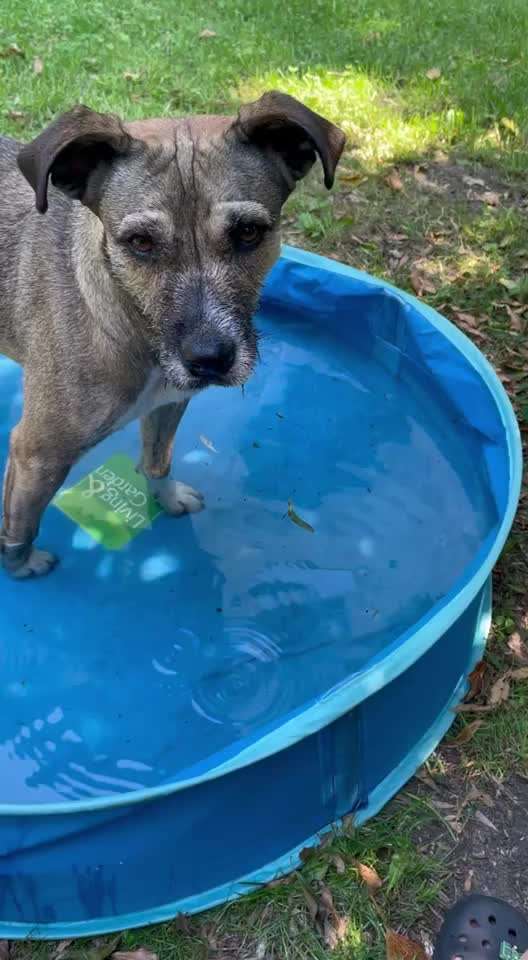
[433,894,528,960]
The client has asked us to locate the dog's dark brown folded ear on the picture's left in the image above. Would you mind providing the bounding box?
[17,106,132,213]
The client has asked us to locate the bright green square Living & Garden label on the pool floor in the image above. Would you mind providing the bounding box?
[53,453,163,550]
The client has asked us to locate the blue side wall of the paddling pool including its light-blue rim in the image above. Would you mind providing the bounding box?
[0,249,521,939]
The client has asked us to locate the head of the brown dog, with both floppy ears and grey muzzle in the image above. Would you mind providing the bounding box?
[18,93,345,390]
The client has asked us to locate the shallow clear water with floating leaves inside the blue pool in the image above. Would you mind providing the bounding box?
[0,308,496,803]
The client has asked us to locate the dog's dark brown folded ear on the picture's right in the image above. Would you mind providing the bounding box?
[235,91,345,189]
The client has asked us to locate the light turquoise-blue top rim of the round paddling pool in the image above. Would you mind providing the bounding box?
[0,246,522,817]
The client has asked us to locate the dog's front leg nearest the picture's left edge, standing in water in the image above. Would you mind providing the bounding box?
[0,424,75,580]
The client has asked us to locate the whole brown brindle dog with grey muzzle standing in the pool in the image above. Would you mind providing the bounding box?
[0,91,345,579]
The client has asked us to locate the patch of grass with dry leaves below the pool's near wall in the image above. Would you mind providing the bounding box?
[13,799,446,960]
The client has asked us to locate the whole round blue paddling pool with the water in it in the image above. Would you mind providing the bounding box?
[0,249,521,938]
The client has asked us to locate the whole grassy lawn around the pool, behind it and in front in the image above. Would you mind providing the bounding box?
[0,0,528,960]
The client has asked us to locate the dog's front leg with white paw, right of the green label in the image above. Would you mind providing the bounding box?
[139,401,204,517]
